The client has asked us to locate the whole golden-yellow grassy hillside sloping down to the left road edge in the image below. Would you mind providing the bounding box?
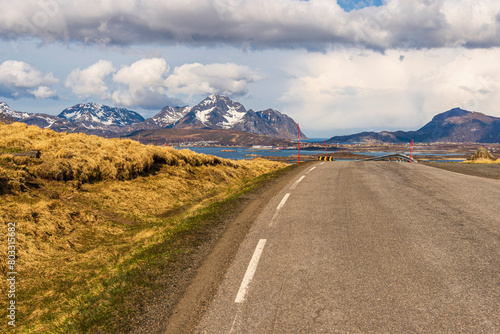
[0,123,284,333]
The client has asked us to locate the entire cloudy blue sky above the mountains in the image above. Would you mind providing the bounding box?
[0,0,500,137]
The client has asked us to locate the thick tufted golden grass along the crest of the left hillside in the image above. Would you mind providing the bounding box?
[0,123,245,183]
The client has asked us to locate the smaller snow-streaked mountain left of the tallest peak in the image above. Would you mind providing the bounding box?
[58,103,144,127]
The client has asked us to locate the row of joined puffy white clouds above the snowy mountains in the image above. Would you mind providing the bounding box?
[63,58,264,109]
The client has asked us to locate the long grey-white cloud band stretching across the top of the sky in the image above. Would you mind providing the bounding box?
[0,0,500,50]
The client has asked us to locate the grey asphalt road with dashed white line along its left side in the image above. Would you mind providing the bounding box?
[197,161,500,333]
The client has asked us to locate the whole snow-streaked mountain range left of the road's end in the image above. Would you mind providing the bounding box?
[0,94,307,140]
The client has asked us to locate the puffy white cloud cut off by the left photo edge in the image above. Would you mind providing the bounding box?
[0,60,59,99]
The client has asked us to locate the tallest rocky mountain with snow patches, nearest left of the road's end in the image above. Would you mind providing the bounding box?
[171,95,307,139]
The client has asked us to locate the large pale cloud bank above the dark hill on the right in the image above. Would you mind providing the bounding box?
[281,48,500,135]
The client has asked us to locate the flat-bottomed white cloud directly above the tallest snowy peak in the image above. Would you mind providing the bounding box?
[165,63,264,96]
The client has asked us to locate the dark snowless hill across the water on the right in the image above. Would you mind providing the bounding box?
[327,108,500,143]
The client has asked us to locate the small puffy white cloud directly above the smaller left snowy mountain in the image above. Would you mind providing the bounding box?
[65,60,115,99]
